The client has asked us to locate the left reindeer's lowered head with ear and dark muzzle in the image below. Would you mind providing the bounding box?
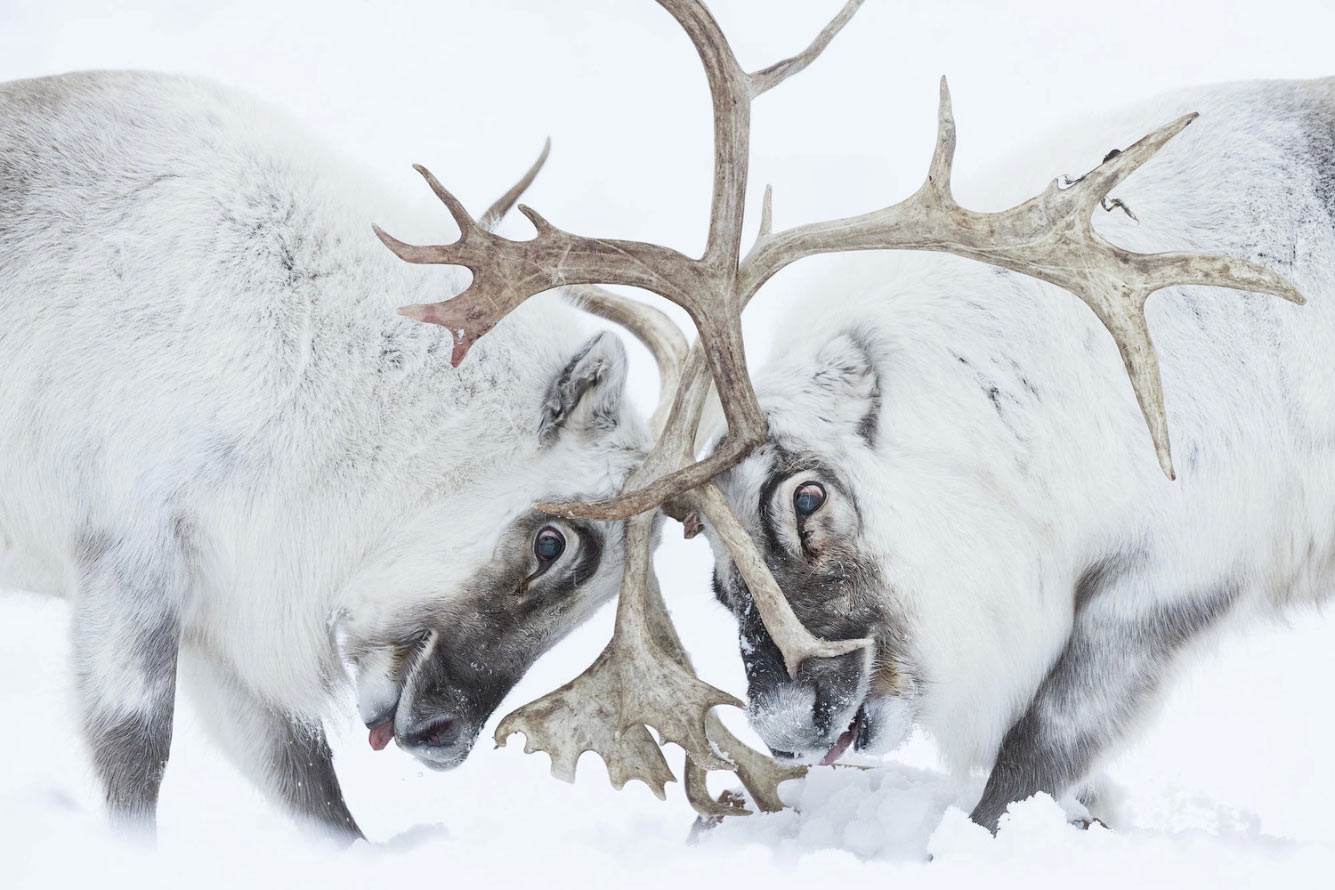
[339,324,650,769]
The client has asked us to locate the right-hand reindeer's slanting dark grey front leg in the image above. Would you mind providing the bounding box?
[971,563,1238,831]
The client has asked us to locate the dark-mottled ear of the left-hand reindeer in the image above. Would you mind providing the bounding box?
[538,331,626,444]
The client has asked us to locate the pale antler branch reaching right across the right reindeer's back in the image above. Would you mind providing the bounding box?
[738,77,1303,479]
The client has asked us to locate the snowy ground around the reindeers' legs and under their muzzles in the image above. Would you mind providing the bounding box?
[0,581,1335,889]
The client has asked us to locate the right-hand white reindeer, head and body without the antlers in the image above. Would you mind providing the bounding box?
[706,79,1335,829]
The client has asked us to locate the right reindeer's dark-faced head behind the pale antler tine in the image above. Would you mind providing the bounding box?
[701,326,920,762]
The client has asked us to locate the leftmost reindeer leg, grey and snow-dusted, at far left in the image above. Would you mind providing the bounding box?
[72,532,182,835]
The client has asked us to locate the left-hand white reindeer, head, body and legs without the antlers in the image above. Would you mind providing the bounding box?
[0,73,667,837]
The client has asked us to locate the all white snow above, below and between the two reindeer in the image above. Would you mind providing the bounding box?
[0,0,1335,889]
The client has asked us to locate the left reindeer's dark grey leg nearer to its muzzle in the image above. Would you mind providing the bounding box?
[183,648,363,842]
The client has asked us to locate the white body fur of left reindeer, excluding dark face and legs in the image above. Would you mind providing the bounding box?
[0,73,643,757]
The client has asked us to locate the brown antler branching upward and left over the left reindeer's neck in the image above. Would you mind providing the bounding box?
[375,0,862,488]
